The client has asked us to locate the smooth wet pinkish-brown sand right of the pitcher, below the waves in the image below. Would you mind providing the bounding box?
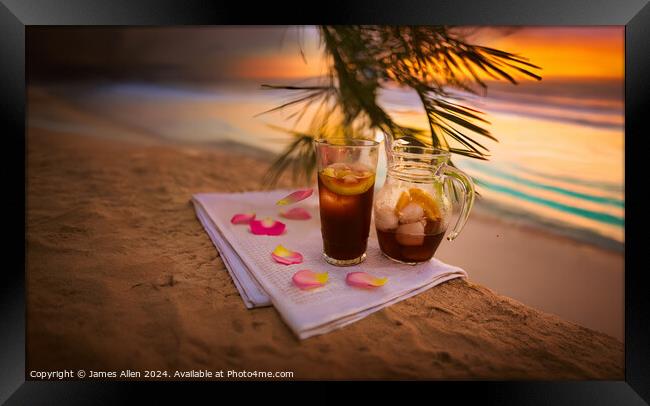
[437,210,625,341]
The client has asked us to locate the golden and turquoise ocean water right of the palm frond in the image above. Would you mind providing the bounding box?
[383,81,625,251]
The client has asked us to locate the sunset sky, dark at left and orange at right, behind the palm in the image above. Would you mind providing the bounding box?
[27,26,624,82]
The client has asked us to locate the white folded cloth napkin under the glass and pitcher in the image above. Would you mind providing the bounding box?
[192,190,467,339]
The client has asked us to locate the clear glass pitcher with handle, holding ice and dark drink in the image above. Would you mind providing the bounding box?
[374,142,474,265]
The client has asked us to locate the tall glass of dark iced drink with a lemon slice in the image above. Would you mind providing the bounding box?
[314,139,379,266]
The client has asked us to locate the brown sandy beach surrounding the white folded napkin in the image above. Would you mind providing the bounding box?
[26,125,624,380]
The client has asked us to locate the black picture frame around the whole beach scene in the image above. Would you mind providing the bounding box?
[0,0,650,405]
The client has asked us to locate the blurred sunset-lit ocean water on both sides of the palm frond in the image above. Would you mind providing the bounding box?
[29,81,625,251]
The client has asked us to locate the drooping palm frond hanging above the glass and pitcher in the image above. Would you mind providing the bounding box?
[256,25,541,188]
